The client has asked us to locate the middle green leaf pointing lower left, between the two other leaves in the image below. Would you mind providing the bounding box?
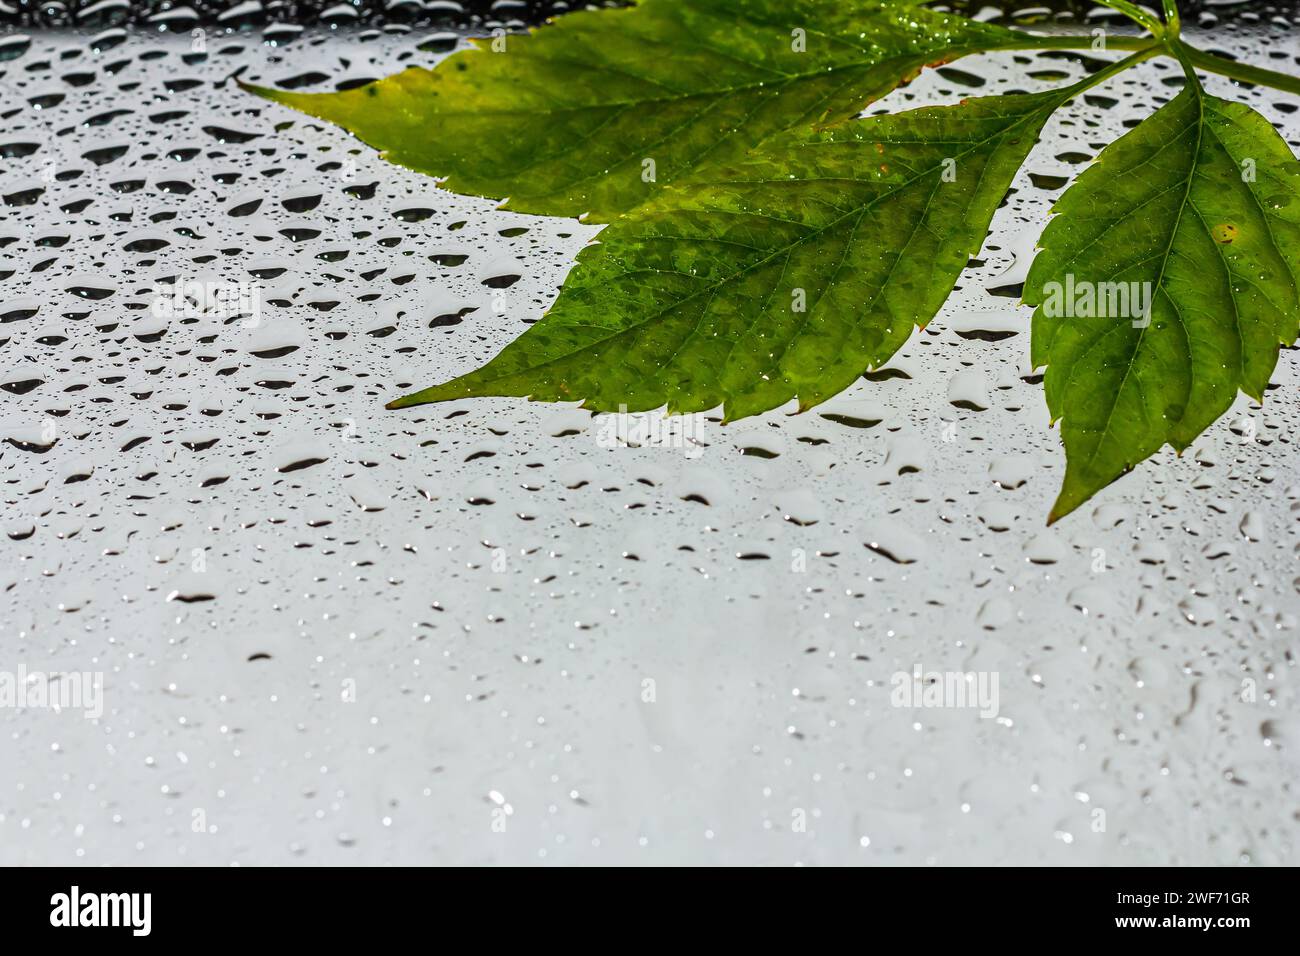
[389,81,1088,420]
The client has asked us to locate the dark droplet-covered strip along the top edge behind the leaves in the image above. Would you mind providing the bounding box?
[0,0,1300,31]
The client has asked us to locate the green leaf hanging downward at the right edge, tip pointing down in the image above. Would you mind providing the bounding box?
[1026,77,1300,522]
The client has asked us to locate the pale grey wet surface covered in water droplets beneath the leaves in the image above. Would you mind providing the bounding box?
[0,8,1300,864]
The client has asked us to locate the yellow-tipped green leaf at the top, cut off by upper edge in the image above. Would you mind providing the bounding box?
[236,0,1026,221]
